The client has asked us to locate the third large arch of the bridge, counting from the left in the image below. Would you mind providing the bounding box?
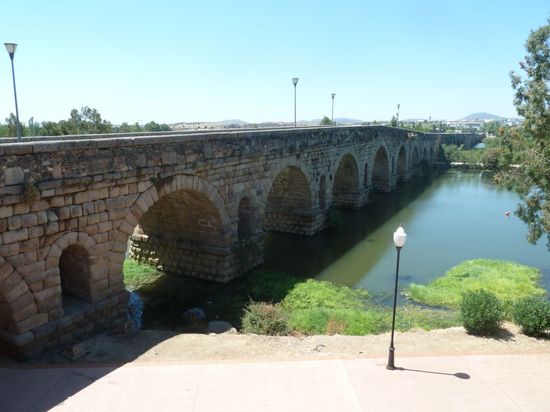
[332,153,361,207]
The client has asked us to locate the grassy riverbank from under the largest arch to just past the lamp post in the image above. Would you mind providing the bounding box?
[124,259,459,335]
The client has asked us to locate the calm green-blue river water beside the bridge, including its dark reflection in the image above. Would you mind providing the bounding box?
[263,170,550,295]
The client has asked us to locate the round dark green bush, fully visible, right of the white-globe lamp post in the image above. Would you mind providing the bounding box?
[460,289,504,334]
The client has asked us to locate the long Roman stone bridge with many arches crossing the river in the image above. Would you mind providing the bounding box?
[0,126,442,356]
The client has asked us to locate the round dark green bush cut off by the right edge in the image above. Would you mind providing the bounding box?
[513,297,550,336]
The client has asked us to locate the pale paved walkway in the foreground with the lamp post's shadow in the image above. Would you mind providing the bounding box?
[0,353,550,412]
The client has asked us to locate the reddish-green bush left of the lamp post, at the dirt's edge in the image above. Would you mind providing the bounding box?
[242,302,289,336]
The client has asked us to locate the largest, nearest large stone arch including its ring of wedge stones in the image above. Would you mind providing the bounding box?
[123,175,238,281]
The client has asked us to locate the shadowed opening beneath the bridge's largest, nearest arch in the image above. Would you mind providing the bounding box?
[129,189,231,281]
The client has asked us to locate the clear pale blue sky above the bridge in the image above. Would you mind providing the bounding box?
[0,0,550,124]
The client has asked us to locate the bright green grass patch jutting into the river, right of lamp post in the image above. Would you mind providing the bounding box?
[405,259,546,307]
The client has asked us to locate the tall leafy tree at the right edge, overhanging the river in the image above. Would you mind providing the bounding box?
[497,19,550,249]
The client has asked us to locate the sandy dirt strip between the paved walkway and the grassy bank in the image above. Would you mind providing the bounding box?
[16,323,550,364]
